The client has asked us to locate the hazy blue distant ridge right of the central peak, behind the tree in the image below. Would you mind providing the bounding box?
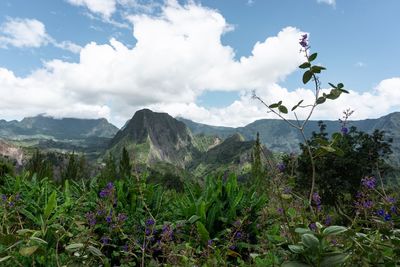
[178,112,400,166]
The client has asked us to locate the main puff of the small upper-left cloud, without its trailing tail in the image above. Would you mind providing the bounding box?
[0,18,49,47]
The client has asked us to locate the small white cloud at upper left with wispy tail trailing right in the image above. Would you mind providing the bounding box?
[0,18,81,53]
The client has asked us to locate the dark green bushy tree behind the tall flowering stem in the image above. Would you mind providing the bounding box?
[296,122,392,205]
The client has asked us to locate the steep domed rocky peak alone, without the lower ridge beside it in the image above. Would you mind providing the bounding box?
[110,109,196,167]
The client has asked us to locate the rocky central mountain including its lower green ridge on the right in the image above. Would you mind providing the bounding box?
[108,109,264,176]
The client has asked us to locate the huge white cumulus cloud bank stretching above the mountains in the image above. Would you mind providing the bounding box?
[0,1,400,126]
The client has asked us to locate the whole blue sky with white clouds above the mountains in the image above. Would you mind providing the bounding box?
[0,0,400,127]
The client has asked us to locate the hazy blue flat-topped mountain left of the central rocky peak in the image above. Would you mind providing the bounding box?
[0,115,118,159]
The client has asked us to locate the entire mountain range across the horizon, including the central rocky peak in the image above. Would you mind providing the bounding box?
[0,109,400,175]
